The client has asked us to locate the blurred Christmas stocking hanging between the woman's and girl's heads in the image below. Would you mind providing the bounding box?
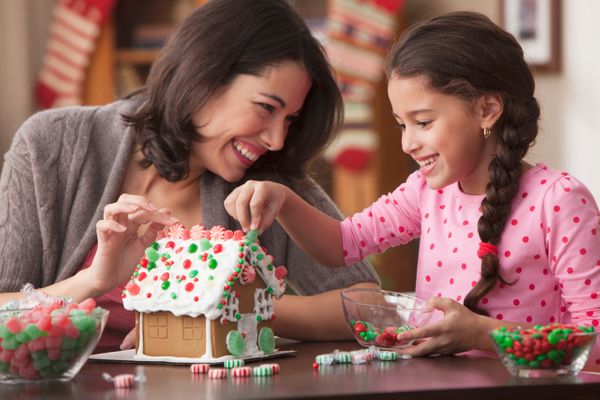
[325,0,403,172]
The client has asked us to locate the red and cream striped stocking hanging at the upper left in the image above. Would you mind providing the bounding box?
[35,0,115,108]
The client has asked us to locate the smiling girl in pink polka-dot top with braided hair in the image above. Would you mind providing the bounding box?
[225,12,600,364]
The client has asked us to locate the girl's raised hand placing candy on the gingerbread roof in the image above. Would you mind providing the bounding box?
[224,181,287,233]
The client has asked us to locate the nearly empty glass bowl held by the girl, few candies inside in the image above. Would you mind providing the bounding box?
[341,289,432,349]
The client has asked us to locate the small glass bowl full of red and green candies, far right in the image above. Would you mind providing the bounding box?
[490,324,598,378]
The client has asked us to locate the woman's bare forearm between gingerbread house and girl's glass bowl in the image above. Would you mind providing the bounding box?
[273,282,378,340]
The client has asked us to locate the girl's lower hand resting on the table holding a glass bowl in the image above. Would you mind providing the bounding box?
[398,297,491,356]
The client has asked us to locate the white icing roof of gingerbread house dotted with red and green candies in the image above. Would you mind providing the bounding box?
[123,225,287,320]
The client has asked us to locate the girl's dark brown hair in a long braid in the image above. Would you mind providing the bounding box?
[386,12,540,315]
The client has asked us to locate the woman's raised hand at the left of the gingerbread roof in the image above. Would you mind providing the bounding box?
[87,194,178,293]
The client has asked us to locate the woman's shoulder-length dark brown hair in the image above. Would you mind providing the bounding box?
[124,0,343,181]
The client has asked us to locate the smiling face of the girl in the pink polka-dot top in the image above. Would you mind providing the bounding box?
[388,75,499,194]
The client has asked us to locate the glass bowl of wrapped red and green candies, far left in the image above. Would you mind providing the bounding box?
[0,302,109,383]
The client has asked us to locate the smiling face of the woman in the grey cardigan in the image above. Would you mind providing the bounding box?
[190,62,312,182]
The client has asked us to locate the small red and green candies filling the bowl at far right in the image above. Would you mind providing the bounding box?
[491,324,595,369]
